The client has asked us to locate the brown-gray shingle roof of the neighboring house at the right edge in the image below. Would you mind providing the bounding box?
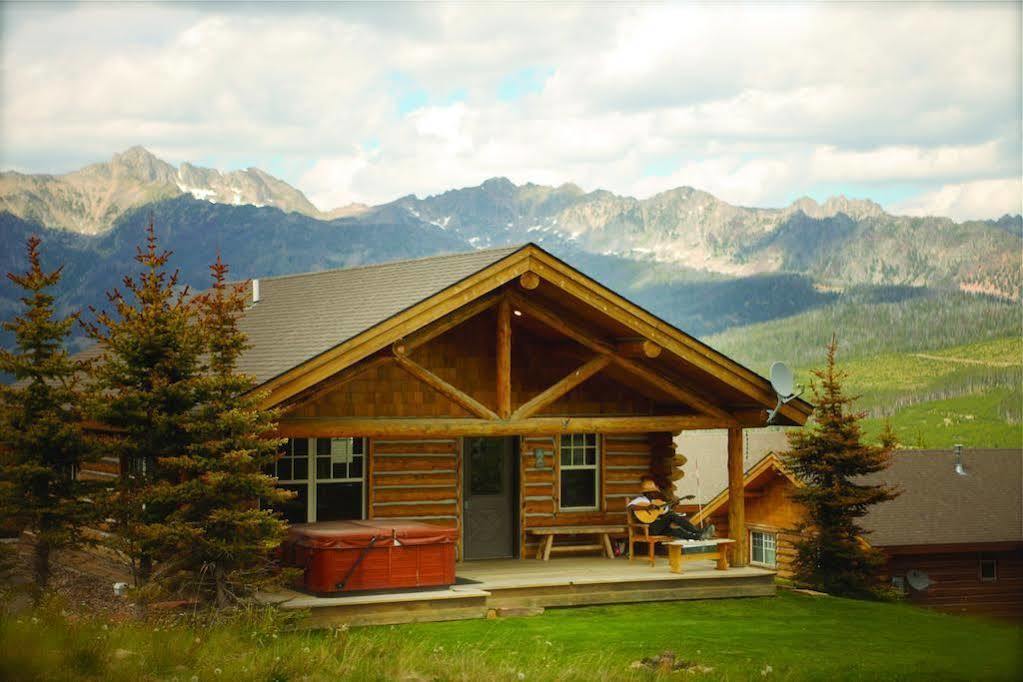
[863,450,1023,547]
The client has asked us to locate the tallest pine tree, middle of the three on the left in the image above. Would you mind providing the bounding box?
[87,218,204,597]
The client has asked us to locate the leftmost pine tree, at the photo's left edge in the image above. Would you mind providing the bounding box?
[0,236,93,604]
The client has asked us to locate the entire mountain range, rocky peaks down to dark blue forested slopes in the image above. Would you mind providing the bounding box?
[0,147,1023,359]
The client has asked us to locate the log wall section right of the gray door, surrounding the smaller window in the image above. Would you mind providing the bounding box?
[519,434,651,558]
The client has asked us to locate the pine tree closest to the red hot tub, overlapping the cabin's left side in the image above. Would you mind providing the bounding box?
[149,256,293,606]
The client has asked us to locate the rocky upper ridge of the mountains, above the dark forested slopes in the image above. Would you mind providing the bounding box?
[0,147,1023,300]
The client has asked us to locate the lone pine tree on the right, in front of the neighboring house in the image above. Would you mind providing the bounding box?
[785,337,898,596]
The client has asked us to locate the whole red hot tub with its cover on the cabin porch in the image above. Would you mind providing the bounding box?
[282,518,457,594]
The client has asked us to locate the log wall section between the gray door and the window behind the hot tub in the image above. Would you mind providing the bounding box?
[366,438,461,554]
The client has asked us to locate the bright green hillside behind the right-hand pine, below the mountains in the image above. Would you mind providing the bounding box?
[708,294,1023,448]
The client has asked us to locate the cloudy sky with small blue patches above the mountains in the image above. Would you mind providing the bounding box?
[0,3,1023,219]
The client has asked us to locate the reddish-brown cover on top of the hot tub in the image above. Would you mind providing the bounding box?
[286,518,457,549]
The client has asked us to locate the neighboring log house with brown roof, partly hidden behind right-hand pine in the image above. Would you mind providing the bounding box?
[694,450,1023,619]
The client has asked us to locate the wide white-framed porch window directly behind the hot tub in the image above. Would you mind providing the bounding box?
[273,438,365,524]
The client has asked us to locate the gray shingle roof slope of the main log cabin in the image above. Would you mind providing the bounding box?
[232,245,523,383]
